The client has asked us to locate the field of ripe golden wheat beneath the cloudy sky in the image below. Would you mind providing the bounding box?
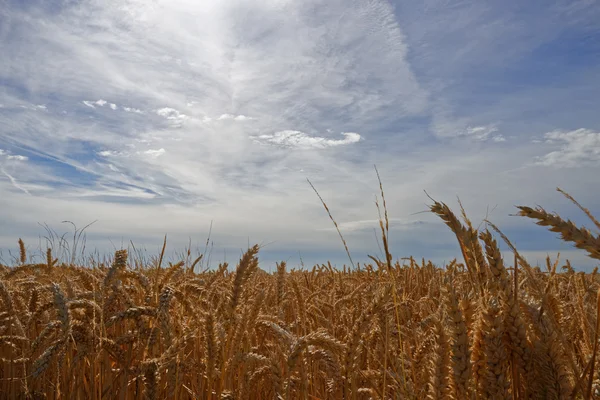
[0,188,600,400]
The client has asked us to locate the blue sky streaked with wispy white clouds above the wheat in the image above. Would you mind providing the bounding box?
[0,0,600,270]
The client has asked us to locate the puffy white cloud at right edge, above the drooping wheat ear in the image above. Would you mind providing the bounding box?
[536,128,600,168]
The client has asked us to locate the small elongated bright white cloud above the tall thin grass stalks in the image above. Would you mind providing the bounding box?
[250,131,361,149]
